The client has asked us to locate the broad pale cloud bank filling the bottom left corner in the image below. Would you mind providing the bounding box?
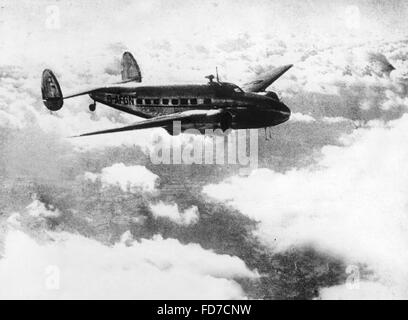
[0,230,258,299]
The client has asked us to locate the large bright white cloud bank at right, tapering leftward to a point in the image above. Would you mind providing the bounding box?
[203,115,408,298]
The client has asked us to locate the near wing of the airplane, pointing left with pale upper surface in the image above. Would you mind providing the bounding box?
[75,109,224,137]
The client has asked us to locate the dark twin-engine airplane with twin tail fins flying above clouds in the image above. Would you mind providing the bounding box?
[41,52,292,136]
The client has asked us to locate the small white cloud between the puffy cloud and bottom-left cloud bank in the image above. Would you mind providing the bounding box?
[150,202,199,225]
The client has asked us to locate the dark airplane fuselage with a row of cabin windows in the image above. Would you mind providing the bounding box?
[90,84,290,129]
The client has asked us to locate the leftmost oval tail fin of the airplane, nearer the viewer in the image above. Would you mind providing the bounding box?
[41,69,64,111]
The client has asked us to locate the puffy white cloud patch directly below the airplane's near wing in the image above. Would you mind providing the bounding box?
[84,163,159,192]
